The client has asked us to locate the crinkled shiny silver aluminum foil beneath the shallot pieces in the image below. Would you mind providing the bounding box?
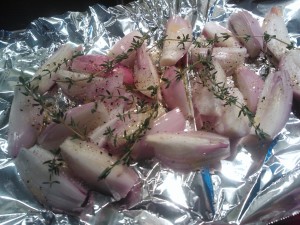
[0,0,300,225]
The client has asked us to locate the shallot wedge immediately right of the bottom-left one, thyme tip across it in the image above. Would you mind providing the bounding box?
[60,138,139,200]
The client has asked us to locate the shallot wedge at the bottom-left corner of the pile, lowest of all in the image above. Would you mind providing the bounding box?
[15,145,88,214]
